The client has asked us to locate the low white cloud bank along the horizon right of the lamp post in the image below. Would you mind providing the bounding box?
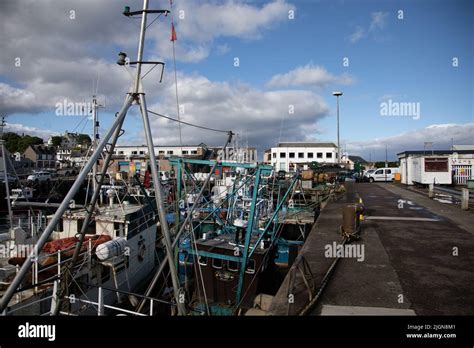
[346,123,474,160]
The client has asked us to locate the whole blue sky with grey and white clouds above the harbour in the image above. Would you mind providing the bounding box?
[0,0,474,160]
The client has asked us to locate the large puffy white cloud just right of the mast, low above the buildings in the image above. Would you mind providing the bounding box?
[143,73,329,150]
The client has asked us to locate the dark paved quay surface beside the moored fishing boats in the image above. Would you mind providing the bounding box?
[270,183,474,315]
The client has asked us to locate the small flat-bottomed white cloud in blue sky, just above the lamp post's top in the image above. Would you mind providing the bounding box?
[267,64,354,87]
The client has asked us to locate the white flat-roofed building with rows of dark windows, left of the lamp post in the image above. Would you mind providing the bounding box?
[271,142,337,171]
